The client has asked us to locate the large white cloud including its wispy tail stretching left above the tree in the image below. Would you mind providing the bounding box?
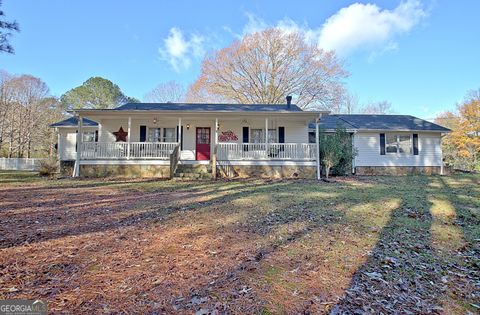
[235,0,427,57]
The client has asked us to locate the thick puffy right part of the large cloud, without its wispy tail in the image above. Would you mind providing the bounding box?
[318,0,427,55]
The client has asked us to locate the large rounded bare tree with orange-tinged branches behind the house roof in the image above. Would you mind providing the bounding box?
[187,28,348,109]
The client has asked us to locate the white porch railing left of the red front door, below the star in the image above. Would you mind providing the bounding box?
[80,142,178,160]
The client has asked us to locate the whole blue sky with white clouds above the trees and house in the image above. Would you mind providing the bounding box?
[0,0,480,118]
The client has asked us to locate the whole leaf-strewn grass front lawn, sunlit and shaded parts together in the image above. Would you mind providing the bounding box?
[0,172,480,314]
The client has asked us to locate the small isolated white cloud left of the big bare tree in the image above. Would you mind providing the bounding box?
[158,27,205,72]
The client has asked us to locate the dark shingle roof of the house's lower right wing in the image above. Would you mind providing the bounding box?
[310,115,450,132]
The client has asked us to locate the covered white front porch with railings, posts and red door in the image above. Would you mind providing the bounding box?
[68,107,318,177]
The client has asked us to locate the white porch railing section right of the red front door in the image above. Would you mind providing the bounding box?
[217,143,316,161]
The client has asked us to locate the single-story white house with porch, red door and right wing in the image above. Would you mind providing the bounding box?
[51,98,449,178]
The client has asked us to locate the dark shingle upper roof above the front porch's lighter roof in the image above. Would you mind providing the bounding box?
[115,103,302,112]
